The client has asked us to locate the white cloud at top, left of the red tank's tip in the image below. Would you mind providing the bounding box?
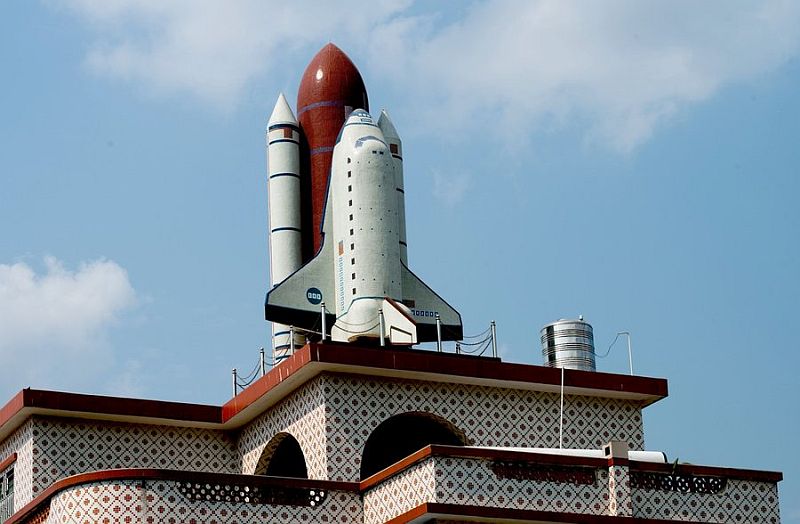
[60,0,412,110]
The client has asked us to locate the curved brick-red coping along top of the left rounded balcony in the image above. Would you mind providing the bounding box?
[5,468,358,524]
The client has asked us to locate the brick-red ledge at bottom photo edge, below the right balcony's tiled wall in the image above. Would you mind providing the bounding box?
[387,502,702,524]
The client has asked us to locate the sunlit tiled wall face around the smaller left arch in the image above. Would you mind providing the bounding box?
[238,377,328,480]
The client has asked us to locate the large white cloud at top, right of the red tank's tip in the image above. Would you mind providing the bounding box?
[374,0,800,152]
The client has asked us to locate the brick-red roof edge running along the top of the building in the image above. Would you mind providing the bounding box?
[0,343,667,440]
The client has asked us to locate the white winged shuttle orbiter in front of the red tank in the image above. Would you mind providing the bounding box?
[265,108,462,345]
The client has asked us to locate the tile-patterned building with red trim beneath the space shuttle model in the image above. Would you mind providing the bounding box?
[0,343,782,523]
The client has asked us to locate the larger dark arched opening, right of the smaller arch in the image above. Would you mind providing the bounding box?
[361,411,469,480]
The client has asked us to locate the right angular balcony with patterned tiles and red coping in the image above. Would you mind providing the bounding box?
[361,446,782,524]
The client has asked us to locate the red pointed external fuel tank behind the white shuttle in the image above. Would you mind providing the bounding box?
[297,44,369,261]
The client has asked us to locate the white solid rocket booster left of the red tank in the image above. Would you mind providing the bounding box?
[267,93,303,363]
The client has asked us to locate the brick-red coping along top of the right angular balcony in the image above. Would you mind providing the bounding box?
[359,444,783,492]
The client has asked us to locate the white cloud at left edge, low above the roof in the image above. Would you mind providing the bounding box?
[0,257,136,390]
